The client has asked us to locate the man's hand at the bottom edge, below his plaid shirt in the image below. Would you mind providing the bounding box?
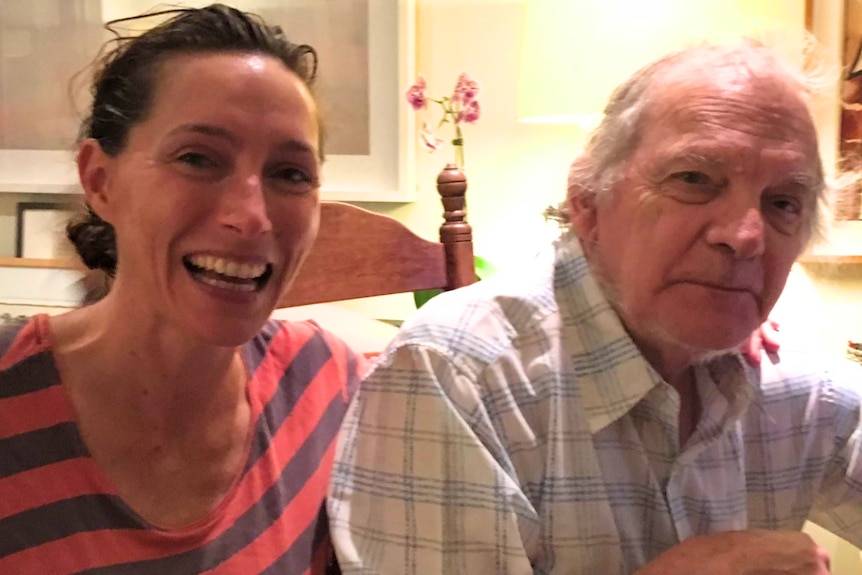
[636,530,830,575]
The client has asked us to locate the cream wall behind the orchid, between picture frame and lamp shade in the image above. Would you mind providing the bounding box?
[340,0,584,318]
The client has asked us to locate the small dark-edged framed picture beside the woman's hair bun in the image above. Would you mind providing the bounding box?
[15,202,77,260]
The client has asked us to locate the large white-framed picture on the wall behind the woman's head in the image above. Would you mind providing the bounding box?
[0,0,415,202]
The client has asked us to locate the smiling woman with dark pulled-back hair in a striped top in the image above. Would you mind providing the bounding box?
[0,5,357,574]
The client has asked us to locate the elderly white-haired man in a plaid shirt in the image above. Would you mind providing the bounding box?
[328,45,862,575]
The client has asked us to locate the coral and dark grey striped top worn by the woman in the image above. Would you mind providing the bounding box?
[0,316,358,575]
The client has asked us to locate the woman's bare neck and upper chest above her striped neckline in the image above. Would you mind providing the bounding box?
[49,302,252,527]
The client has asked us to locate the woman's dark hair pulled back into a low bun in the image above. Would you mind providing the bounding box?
[66,4,322,276]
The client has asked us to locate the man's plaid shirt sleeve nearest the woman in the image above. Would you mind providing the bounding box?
[327,345,537,575]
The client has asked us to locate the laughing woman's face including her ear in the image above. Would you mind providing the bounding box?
[79,53,320,345]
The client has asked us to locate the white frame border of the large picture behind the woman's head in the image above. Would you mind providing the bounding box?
[0,0,416,202]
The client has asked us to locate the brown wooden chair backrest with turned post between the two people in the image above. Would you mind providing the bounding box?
[277,165,476,308]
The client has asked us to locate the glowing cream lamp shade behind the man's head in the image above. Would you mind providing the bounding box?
[518,0,805,123]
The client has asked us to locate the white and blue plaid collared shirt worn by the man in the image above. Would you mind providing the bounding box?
[328,236,862,575]
